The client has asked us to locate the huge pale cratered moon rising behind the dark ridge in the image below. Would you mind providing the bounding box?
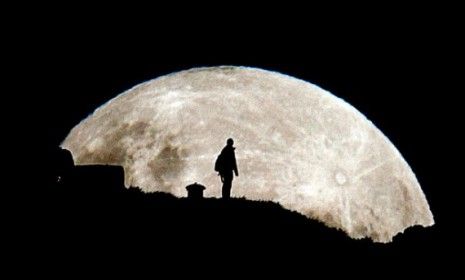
[62,67,434,242]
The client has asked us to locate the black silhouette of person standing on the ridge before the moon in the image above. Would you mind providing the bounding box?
[215,138,239,199]
